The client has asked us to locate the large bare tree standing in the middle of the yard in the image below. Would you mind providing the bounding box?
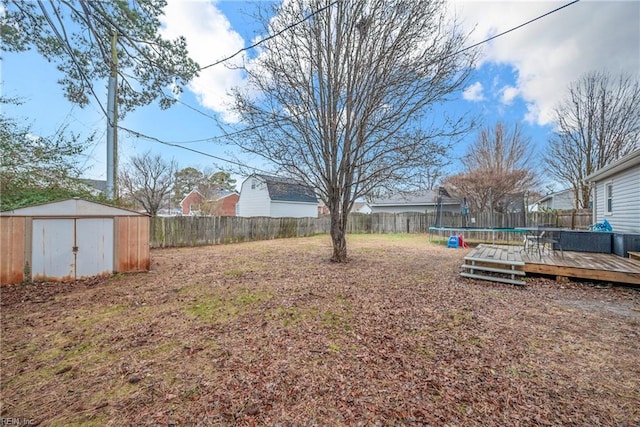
[228,0,474,262]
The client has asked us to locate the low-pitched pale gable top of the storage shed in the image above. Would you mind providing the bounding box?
[0,198,146,217]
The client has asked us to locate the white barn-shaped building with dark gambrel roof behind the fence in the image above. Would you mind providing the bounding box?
[236,174,318,218]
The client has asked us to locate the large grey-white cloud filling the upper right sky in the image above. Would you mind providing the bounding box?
[456,0,640,125]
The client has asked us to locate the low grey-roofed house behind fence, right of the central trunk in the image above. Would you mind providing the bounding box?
[369,190,462,213]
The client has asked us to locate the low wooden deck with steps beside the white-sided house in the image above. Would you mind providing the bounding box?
[463,244,640,285]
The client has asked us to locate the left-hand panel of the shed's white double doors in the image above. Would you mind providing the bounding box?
[31,219,75,280]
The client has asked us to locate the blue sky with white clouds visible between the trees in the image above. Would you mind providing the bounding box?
[1,0,640,190]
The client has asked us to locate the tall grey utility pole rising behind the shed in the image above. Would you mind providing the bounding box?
[107,32,118,200]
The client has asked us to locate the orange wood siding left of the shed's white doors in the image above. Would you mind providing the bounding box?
[0,217,26,285]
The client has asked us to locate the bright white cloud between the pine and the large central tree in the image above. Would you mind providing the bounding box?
[162,0,244,122]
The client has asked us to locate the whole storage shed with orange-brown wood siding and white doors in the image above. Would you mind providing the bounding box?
[0,199,150,285]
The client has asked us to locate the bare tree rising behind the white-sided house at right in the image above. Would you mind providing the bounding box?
[544,72,640,208]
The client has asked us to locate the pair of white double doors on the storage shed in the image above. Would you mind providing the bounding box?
[32,218,113,280]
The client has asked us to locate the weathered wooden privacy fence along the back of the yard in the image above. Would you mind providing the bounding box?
[150,211,591,248]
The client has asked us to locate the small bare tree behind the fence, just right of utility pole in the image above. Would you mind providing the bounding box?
[120,151,177,216]
